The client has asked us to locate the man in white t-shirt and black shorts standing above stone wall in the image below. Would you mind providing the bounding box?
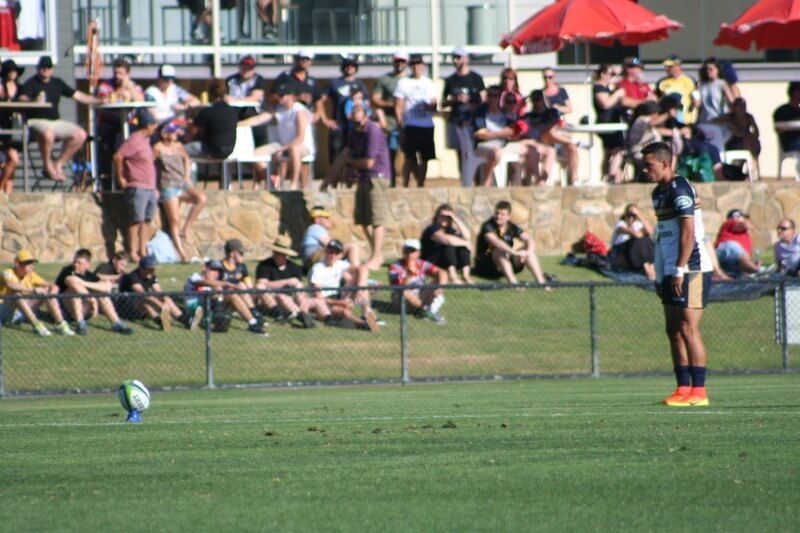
[393,55,437,187]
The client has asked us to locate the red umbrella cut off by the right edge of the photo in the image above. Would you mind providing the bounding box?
[714,0,800,50]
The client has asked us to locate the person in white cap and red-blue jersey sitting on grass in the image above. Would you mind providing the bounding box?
[389,239,447,325]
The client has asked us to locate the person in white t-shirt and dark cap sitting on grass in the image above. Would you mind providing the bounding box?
[308,239,378,332]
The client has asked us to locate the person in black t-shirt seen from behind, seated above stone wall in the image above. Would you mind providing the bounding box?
[186,78,239,159]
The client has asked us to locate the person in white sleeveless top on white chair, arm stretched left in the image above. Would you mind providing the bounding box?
[239,85,316,191]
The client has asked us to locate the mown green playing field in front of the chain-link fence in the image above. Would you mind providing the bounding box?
[0,374,800,532]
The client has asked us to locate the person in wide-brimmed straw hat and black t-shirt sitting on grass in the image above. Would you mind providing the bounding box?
[256,235,324,328]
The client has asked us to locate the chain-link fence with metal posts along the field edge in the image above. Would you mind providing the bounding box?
[0,281,800,394]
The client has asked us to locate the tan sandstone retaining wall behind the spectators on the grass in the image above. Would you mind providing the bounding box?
[0,180,800,263]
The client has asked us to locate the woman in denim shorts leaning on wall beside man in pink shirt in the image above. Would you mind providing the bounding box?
[153,123,208,263]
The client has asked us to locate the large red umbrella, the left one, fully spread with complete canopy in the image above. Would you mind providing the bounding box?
[500,0,682,54]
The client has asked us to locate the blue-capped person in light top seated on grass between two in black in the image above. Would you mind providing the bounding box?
[183,259,264,335]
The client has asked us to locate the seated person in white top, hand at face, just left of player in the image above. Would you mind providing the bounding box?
[609,204,656,281]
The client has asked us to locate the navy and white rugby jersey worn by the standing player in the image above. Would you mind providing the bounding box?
[653,176,712,283]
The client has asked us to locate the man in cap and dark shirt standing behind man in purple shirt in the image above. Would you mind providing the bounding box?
[321,56,369,163]
